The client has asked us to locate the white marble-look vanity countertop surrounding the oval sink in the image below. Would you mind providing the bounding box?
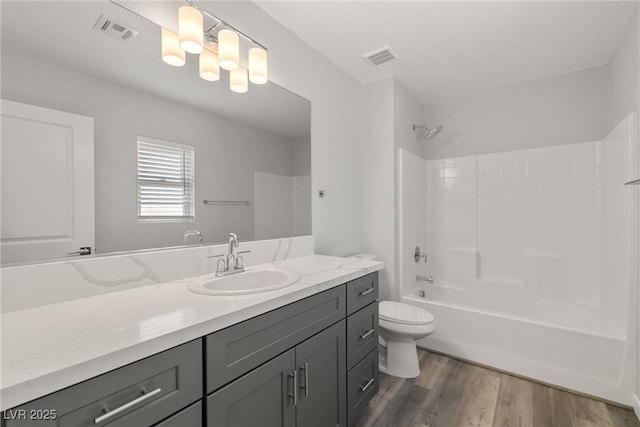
[0,255,383,410]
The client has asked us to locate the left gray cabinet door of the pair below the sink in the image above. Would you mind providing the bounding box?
[207,349,295,427]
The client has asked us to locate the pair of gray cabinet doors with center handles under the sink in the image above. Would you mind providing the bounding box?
[207,320,346,427]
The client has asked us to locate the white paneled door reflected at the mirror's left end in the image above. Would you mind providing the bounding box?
[0,100,95,264]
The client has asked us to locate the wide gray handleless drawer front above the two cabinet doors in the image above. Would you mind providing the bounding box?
[205,286,346,393]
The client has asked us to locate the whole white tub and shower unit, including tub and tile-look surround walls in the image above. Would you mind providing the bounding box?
[398,113,640,405]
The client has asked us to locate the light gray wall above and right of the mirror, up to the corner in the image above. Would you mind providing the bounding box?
[214,1,366,255]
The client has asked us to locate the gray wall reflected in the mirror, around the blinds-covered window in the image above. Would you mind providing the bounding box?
[2,50,298,253]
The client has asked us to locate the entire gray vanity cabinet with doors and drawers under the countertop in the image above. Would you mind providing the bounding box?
[1,273,378,427]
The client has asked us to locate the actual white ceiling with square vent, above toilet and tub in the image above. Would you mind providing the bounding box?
[256,0,638,105]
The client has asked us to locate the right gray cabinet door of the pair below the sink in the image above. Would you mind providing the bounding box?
[296,320,346,427]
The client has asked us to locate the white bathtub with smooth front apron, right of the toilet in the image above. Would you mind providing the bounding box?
[401,294,635,405]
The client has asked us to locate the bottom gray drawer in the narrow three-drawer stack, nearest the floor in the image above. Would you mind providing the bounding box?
[347,347,378,426]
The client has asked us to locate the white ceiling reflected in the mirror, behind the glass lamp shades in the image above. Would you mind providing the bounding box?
[0,0,311,138]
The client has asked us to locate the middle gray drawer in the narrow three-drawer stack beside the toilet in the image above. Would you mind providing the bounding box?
[347,301,378,369]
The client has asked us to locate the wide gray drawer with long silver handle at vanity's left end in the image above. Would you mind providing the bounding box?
[3,340,202,427]
